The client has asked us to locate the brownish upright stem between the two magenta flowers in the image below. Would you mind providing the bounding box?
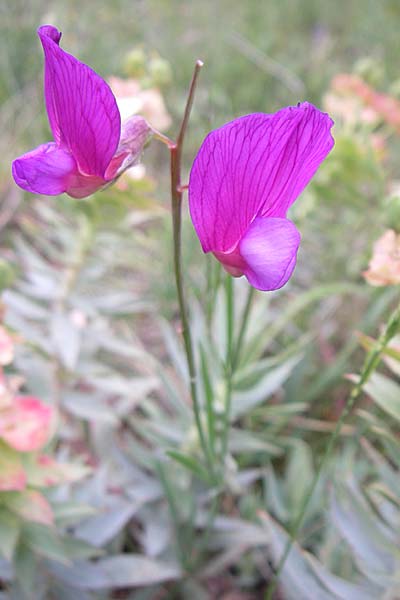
[167,60,213,472]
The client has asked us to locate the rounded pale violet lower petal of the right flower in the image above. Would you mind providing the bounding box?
[239,217,301,291]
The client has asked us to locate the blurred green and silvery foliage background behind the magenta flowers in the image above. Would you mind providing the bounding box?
[0,0,400,600]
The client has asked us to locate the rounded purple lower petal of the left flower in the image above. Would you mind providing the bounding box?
[12,142,76,196]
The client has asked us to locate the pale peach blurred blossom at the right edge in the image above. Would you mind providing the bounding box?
[363,229,400,287]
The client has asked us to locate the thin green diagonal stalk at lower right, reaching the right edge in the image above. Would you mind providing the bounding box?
[265,304,400,600]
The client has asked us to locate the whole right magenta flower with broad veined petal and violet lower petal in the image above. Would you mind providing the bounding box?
[189,102,334,291]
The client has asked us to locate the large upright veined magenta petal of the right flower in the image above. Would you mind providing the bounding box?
[189,102,334,252]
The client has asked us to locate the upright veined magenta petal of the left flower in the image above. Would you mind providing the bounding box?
[38,25,121,177]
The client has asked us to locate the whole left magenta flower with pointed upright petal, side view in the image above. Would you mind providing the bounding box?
[12,25,151,198]
